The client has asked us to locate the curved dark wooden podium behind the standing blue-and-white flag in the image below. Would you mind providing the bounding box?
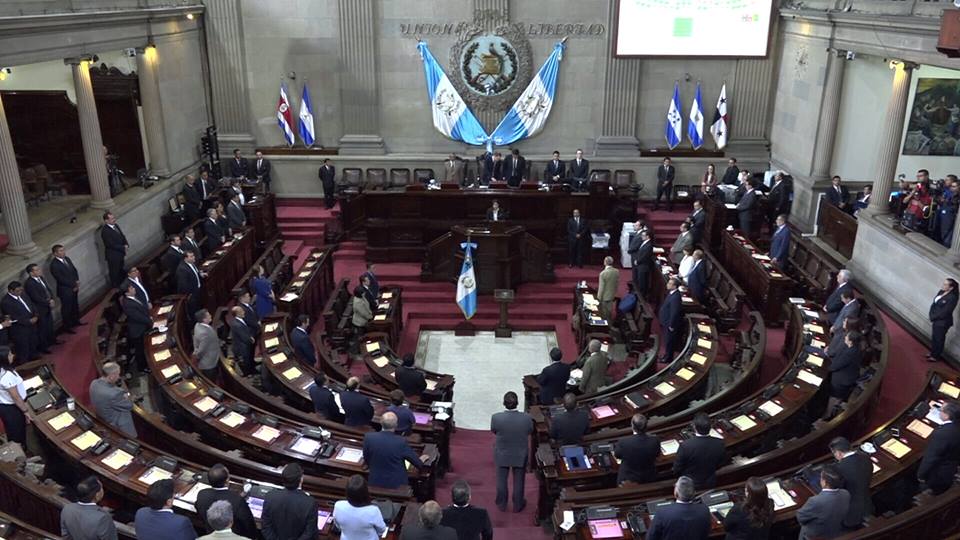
[420,222,556,294]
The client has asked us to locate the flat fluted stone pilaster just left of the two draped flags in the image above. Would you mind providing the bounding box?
[337,0,386,155]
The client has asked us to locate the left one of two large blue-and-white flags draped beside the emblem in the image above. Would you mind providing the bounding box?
[417,41,489,145]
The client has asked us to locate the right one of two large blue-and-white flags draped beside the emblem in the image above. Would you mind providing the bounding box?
[490,40,566,146]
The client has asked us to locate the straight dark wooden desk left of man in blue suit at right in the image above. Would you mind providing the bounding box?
[721,231,795,326]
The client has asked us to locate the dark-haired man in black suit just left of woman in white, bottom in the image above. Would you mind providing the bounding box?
[260,463,317,540]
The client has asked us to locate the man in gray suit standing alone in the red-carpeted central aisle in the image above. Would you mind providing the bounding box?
[490,392,533,512]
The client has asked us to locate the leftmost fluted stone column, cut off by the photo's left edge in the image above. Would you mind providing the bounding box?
[0,94,40,256]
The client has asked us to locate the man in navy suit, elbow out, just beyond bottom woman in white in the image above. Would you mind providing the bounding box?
[363,412,428,489]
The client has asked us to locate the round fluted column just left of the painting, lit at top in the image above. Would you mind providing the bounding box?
[870,62,917,214]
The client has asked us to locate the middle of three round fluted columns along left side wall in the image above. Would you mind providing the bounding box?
[64,58,113,209]
